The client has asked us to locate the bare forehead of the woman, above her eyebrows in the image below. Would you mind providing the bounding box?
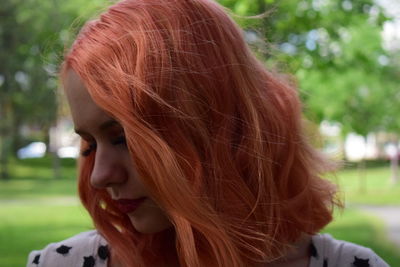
[63,69,111,130]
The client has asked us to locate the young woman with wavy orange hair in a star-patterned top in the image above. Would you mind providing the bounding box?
[28,0,387,267]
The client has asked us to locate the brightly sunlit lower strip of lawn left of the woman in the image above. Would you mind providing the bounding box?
[0,204,91,267]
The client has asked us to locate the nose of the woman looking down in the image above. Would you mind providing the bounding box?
[90,146,127,189]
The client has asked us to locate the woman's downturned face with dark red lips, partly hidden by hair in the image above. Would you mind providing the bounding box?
[64,69,172,233]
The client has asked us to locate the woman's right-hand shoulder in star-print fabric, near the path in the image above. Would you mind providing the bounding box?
[310,234,389,267]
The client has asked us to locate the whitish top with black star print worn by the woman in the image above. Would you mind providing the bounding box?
[27,230,389,267]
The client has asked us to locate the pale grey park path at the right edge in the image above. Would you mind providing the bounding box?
[357,205,400,250]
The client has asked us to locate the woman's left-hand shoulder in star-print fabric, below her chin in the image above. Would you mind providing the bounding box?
[27,230,108,267]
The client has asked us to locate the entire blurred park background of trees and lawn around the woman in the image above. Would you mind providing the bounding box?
[0,0,400,267]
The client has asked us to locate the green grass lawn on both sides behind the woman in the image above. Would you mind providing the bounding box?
[0,158,400,267]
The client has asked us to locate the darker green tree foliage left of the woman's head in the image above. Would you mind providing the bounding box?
[0,0,106,179]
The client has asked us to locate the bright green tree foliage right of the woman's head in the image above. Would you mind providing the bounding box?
[219,0,400,135]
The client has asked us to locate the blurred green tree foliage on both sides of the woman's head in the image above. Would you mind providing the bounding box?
[0,0,400,177]
